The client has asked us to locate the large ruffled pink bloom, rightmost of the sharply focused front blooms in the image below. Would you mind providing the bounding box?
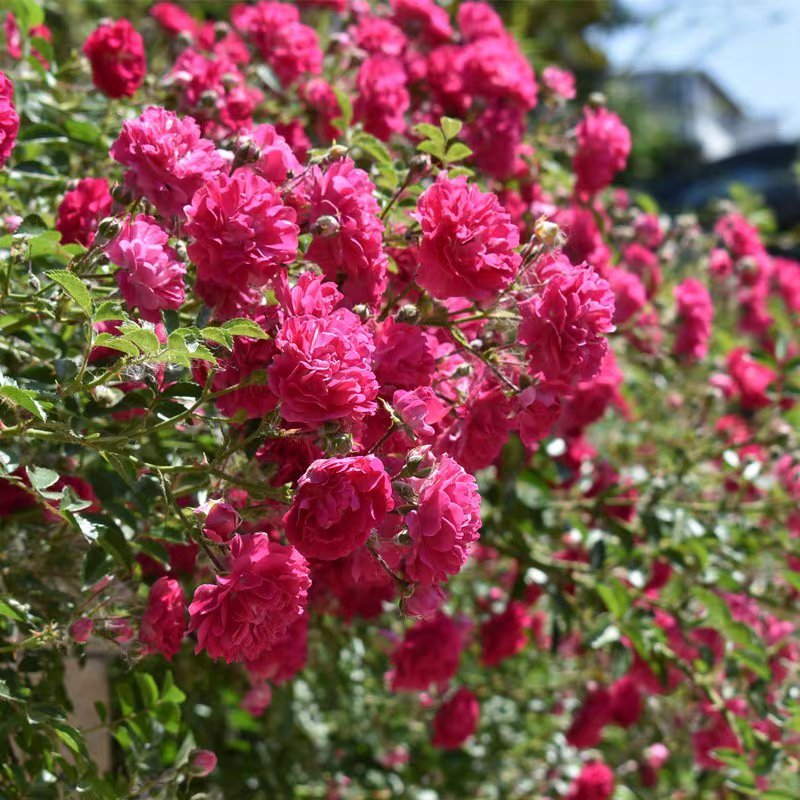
[519,255,614,388]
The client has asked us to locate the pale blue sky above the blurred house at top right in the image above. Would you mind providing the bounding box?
[588,0,800,139]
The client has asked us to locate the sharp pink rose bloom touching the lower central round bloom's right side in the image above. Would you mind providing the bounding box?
[406,455,481,584]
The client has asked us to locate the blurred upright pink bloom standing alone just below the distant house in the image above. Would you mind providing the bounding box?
[572,108,631,194]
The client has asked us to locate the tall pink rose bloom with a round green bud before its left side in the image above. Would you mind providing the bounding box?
[306,158,388,305]
